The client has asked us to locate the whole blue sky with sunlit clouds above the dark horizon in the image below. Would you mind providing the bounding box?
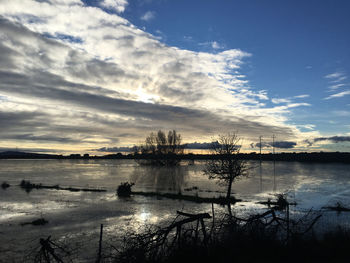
[0,0,350,154]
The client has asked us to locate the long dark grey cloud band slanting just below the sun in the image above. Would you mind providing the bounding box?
[0,67,291,139]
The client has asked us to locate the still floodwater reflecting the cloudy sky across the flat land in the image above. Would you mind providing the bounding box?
[0,160,350,262]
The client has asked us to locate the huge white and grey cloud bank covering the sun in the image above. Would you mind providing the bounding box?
[0,0,314,151]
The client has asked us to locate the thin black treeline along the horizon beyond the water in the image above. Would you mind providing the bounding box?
[0,152,350,163]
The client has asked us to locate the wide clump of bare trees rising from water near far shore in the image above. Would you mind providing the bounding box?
[139,130,184,165]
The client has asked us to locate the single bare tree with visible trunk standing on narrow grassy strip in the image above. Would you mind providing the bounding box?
[204,133,248,199]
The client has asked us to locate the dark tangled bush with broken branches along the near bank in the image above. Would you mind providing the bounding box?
[110,206,350,263]
